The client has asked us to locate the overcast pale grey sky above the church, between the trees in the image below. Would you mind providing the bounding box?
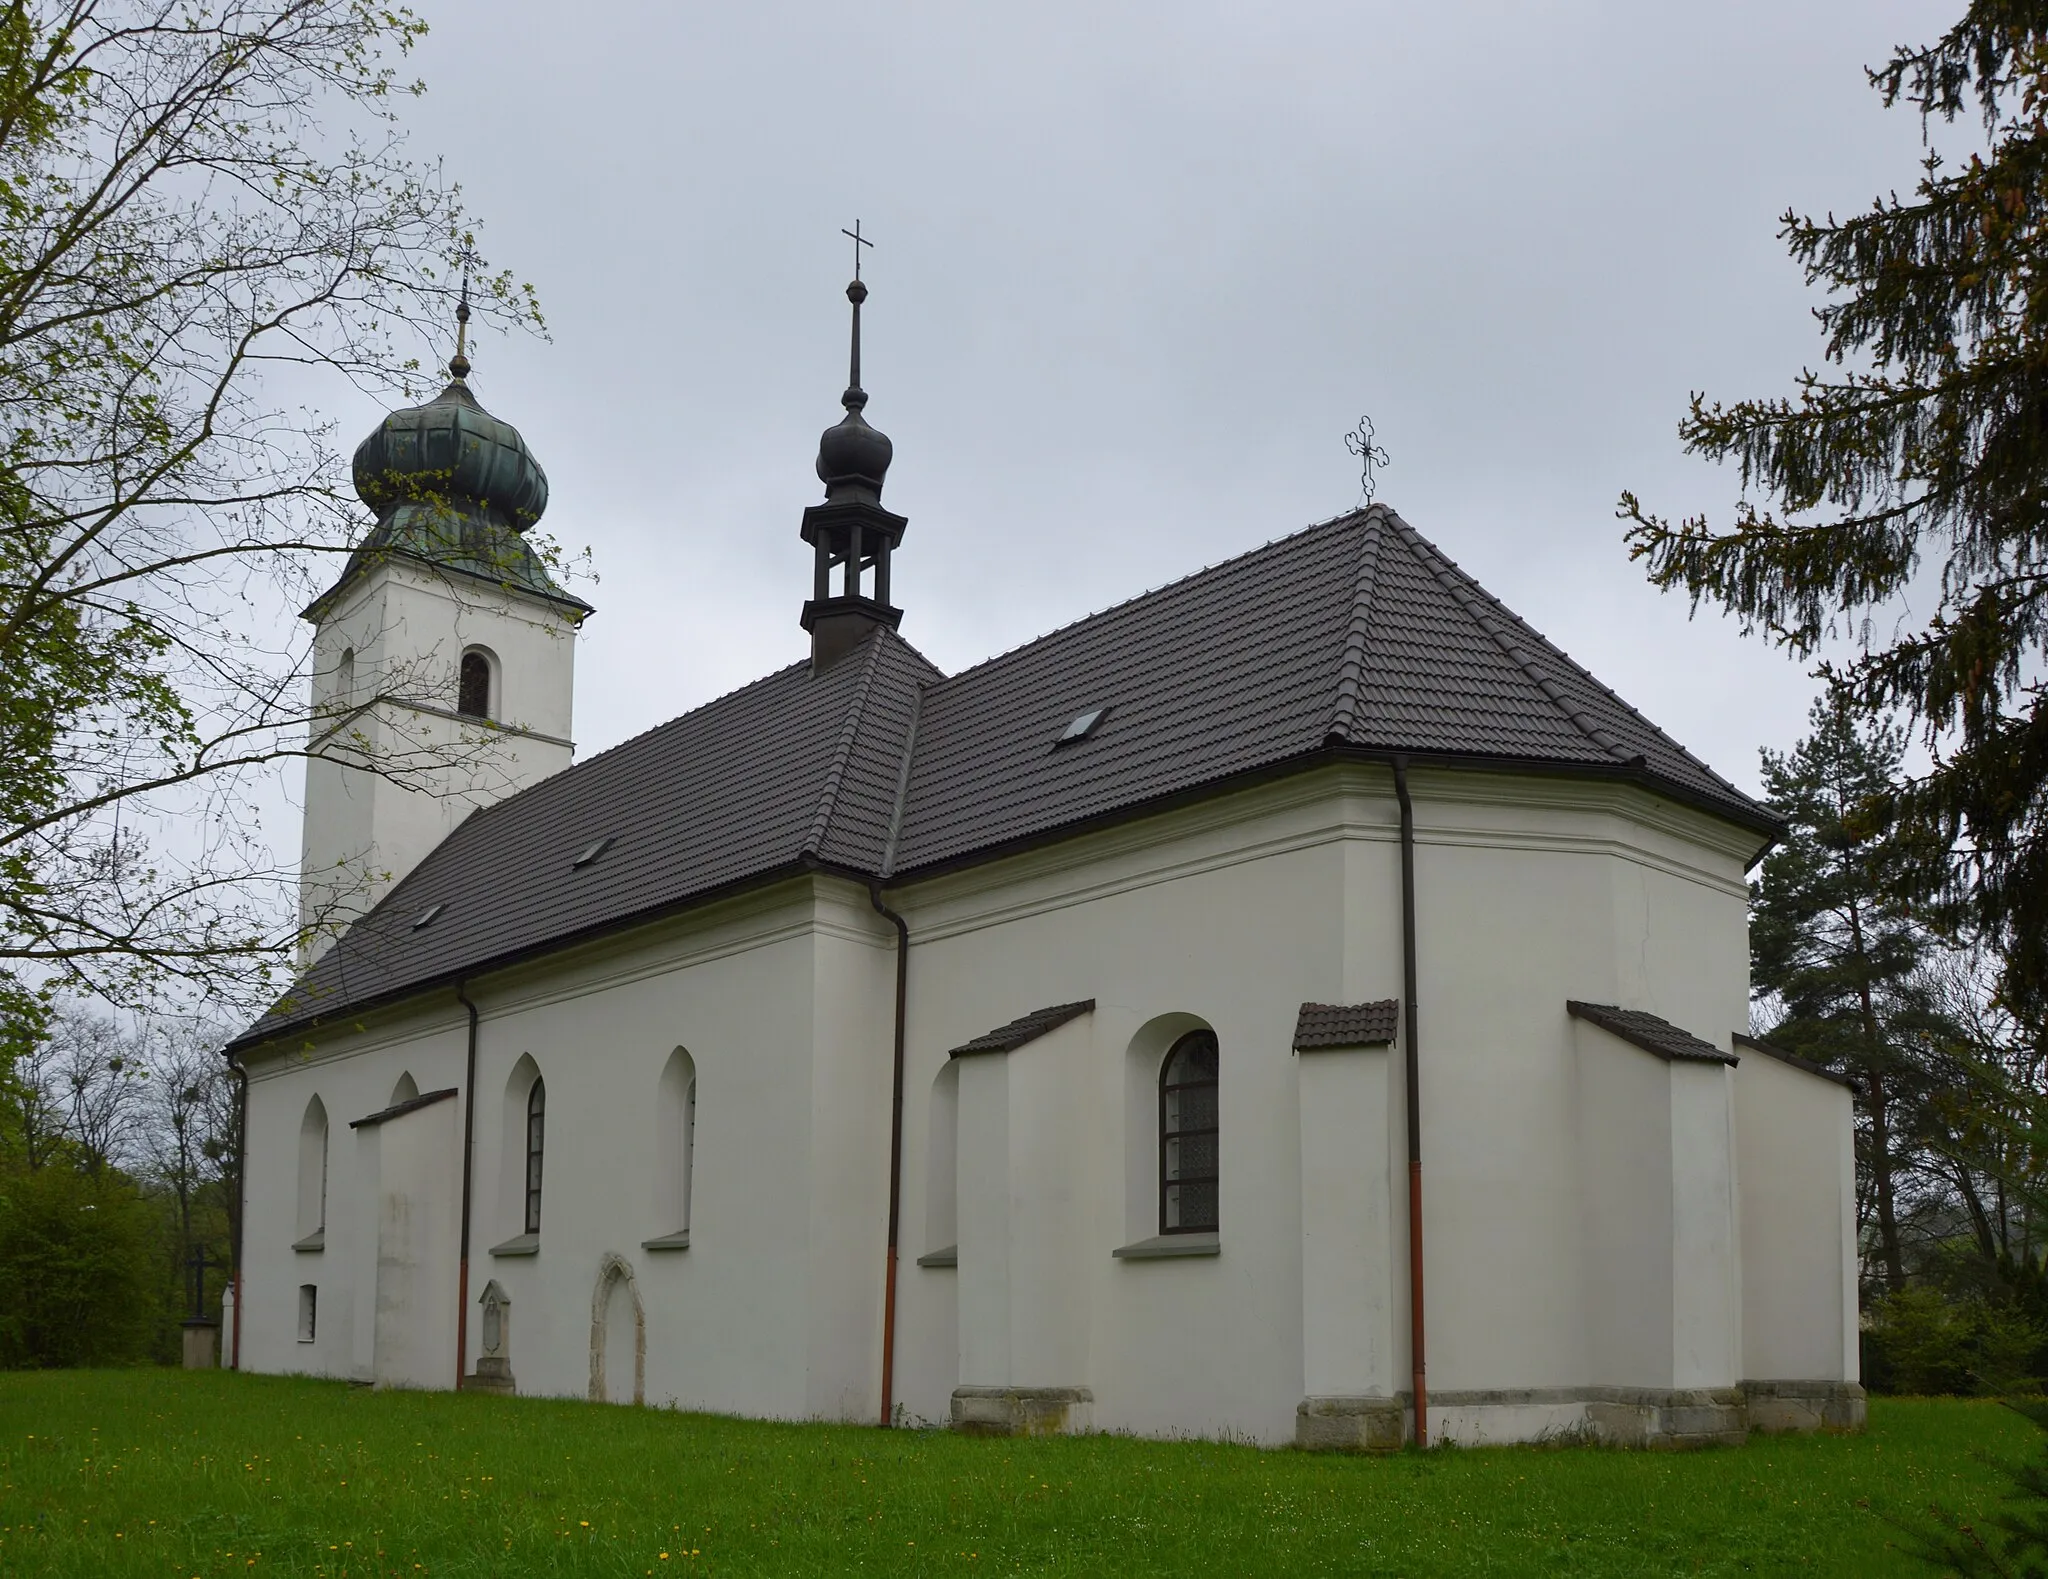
[336,0,1958,786]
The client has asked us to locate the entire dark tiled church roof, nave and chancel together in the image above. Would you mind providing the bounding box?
[244,506,1776,1040]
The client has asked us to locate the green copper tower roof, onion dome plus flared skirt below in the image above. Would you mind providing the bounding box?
[305,378,590,621]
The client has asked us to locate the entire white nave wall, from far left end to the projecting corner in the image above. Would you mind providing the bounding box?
[244,879,893,1419]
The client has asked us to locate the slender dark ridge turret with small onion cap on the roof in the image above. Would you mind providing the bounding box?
[801,221,909,670]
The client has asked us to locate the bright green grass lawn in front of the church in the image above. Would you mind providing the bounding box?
[0,1370,2042,1579]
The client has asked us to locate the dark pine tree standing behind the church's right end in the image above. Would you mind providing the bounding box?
[1749,700,1929,1292]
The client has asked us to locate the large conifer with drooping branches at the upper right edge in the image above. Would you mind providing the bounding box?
[1620,0,2048,1019]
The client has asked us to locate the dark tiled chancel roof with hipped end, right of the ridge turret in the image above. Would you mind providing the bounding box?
[895,508,1772,877]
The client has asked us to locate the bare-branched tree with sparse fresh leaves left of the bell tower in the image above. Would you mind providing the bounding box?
[0,0,539,1047]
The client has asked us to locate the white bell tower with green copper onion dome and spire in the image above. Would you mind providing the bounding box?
[299,292,592,965]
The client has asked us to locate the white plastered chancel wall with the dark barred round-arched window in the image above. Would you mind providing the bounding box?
[897,770,1777,1442]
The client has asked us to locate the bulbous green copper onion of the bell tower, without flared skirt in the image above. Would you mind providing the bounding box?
[354,374,548,532]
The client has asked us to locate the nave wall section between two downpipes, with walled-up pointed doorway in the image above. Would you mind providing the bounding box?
[444,883,893,1419]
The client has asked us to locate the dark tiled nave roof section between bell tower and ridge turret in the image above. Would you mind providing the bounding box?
[248,637,938,1036]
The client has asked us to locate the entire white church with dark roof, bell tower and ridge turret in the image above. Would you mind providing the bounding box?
[227,268,1864,1448]
